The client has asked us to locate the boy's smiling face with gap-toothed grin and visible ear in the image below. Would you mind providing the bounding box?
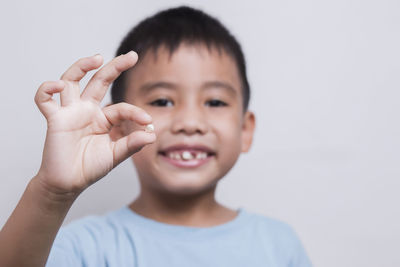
[122,45,254,195]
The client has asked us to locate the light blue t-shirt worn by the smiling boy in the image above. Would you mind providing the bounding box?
[46,206,311,267]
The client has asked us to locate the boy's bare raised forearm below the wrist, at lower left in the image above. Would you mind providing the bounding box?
[0,178,77,267]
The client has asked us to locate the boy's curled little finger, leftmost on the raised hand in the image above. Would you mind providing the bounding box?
[35,81,65,118]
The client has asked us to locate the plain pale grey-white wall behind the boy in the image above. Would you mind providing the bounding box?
[0,0,400,267]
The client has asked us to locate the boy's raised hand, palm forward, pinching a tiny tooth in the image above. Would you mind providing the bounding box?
[35,52,156,198]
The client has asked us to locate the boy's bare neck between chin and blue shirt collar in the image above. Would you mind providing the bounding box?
[129,186,237,227]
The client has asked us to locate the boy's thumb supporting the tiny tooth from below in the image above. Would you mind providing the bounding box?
[113,130,156,166]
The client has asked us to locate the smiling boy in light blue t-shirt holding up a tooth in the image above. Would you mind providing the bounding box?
[0,7,311,267]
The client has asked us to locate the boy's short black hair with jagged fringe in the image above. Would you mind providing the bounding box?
[111,6,250,111]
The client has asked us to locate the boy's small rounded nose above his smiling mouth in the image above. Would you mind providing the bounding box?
[172,103,208,135]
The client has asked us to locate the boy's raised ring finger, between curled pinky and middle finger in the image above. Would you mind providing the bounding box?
[60,54,103,106]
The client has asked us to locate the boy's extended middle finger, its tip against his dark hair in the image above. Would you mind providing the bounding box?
[82,51,138,102]
